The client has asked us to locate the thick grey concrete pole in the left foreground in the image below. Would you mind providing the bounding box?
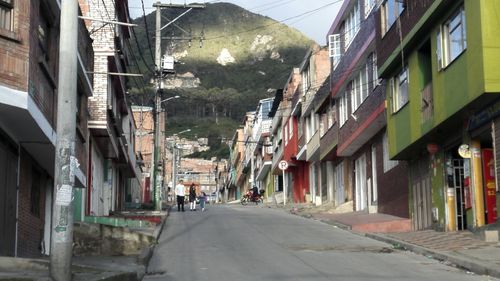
[50,1,78,281]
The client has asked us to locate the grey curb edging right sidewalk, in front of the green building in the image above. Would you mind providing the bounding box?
[365,233,500,278]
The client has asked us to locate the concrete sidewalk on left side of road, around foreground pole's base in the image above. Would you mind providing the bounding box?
[0,208,169,281]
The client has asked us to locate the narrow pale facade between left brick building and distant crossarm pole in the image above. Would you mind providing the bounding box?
[82,0,140,219]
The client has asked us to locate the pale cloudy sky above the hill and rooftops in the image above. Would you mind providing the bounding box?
[129,0,343,45]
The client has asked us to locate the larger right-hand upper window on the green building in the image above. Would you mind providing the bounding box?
[437,6,467,69]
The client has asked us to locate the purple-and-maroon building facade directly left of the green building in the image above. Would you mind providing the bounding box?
[317,0,408,215]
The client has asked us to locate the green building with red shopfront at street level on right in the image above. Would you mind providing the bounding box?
[376,0,500,231]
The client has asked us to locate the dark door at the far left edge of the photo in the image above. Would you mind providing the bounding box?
[0,136,18,256]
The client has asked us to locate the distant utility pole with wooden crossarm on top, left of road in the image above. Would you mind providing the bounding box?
[153,2,205,211]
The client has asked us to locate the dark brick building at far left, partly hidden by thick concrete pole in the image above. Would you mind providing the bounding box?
[0,0,93,257]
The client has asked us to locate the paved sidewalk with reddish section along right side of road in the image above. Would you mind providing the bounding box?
[284,205,500,278]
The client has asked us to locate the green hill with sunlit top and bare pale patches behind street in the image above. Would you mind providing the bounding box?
[129,3,313,155]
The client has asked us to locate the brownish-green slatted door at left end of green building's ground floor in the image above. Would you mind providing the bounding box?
[410,159,432,230]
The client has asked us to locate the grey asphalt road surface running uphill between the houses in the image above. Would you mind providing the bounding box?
[143,205,498,281]
